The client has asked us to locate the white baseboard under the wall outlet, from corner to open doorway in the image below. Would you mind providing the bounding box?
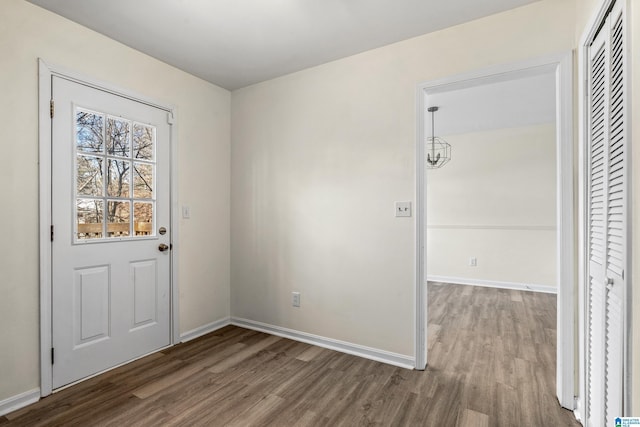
[231,317,415,369]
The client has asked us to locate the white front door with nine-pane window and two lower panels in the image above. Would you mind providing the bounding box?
[51,77,171,389]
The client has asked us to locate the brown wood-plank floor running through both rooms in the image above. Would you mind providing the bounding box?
[0,284,579,427]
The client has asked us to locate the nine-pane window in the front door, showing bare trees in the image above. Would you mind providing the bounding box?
[76,109,155,239]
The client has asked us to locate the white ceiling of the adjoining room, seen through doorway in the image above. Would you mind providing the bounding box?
[425,71,556,136]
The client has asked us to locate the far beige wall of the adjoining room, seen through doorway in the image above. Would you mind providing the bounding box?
[426,123,557,287]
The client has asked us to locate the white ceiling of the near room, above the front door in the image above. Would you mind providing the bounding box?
[28,0,538,90]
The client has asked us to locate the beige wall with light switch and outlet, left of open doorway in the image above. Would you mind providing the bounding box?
[231,0,576,356]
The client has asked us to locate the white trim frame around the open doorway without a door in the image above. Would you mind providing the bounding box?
[415,52,576,409]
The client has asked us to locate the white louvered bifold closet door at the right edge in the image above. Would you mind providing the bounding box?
[587,2,628,427]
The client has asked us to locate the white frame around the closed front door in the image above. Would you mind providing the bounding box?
[38,59,180,397]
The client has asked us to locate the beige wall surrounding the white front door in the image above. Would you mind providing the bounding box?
[0,0,230,401]
